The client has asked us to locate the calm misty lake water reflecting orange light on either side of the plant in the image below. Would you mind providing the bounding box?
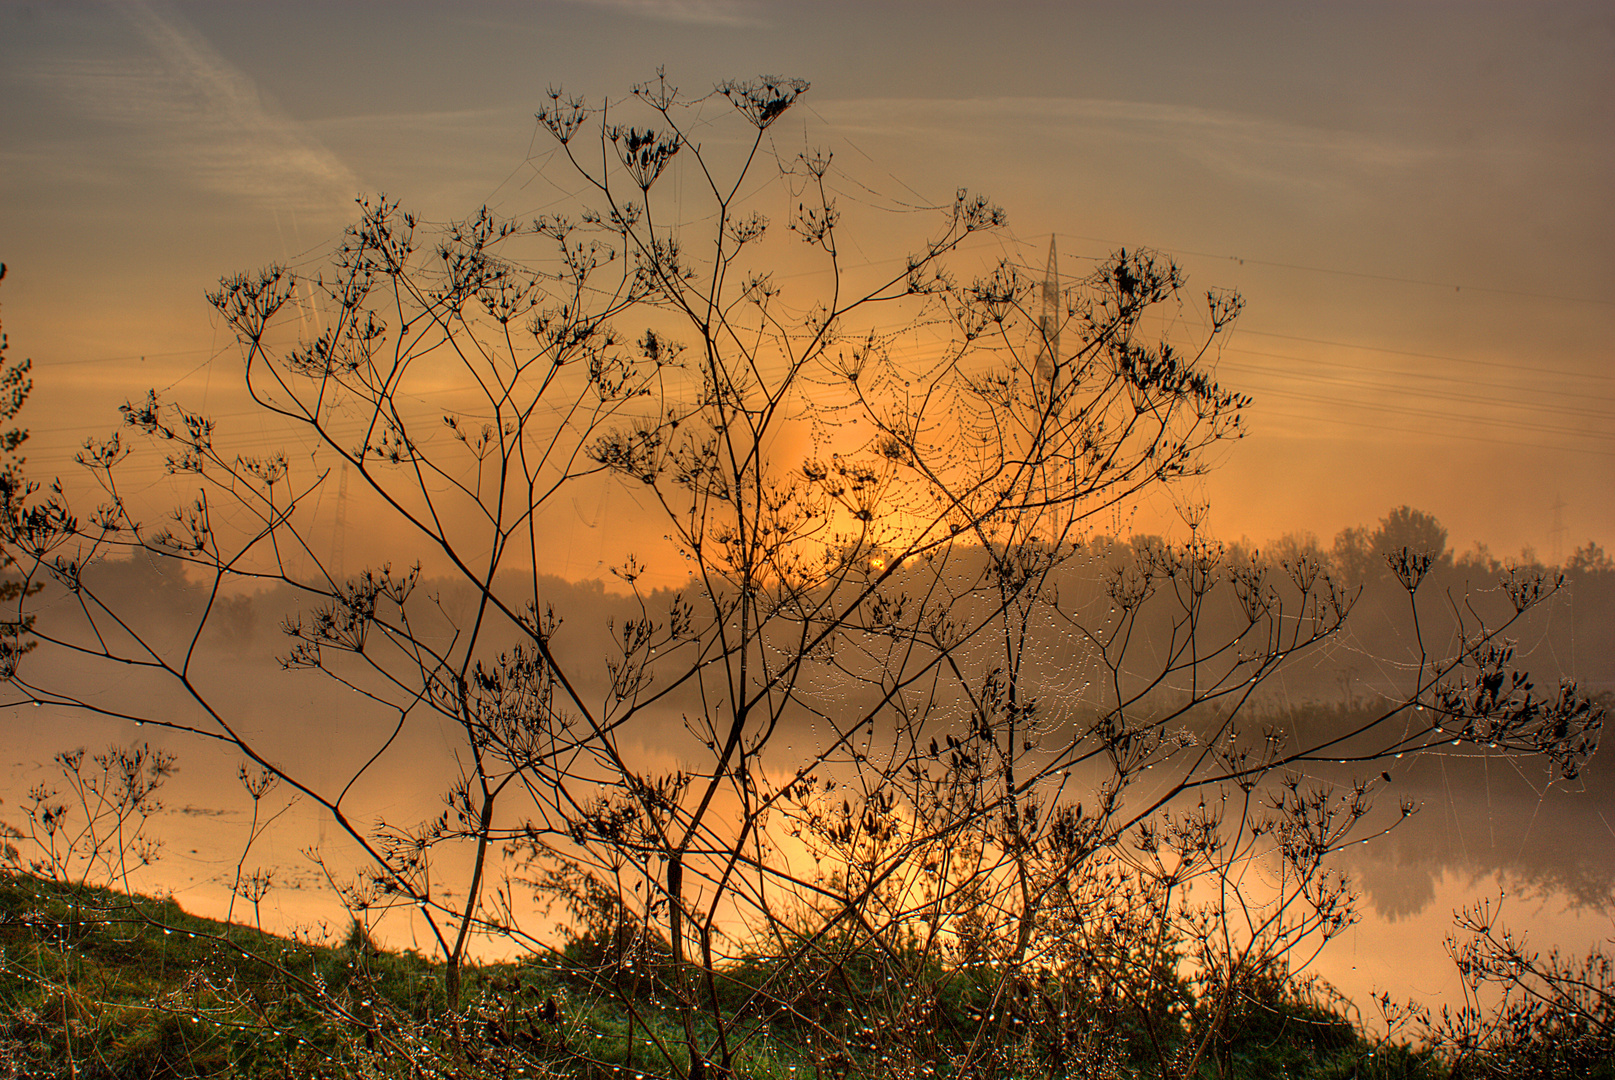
[0,690,1615,1025]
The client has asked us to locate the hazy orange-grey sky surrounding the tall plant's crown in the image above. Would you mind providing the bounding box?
[0,0,1615,565]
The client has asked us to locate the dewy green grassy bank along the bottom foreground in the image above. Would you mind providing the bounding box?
[0,875,1449,1080]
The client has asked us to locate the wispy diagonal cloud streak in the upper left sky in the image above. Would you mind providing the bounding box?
[32,2,362,211]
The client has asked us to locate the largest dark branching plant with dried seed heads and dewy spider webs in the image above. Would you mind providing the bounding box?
[0,76,1604,1080]
